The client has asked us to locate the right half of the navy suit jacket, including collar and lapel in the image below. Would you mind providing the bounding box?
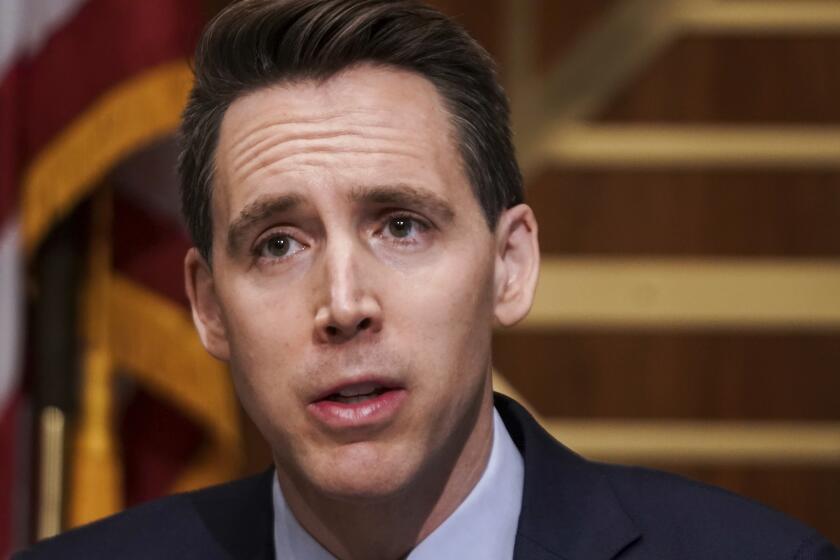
[495,395,840,560]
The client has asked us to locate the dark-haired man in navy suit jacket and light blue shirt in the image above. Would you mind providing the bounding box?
[18,0,840,560]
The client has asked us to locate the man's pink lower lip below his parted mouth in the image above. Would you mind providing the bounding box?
[308,389,406,429]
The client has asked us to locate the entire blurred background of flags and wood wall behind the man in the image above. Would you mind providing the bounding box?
[0,0,840,556]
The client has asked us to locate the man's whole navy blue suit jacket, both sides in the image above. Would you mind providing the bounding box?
[17,395,840,560]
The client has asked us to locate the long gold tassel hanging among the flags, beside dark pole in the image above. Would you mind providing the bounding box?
[67,187,123,527]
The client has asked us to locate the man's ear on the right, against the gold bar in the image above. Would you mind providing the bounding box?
[494,204,540,327]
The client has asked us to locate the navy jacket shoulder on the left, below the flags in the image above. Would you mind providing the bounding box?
[15,473,271,560]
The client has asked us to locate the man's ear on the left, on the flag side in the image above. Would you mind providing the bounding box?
[184,247,230,362]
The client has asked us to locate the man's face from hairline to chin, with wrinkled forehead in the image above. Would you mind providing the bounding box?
[194,66,520,498]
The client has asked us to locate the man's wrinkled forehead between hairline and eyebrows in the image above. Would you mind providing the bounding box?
[214,65,462,213]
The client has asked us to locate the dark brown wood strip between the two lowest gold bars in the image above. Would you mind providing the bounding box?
[494,331,840,420]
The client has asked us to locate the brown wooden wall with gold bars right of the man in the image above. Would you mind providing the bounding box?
[435,0,840,541]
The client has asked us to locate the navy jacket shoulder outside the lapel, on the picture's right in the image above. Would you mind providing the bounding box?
[592,463,840,560]
